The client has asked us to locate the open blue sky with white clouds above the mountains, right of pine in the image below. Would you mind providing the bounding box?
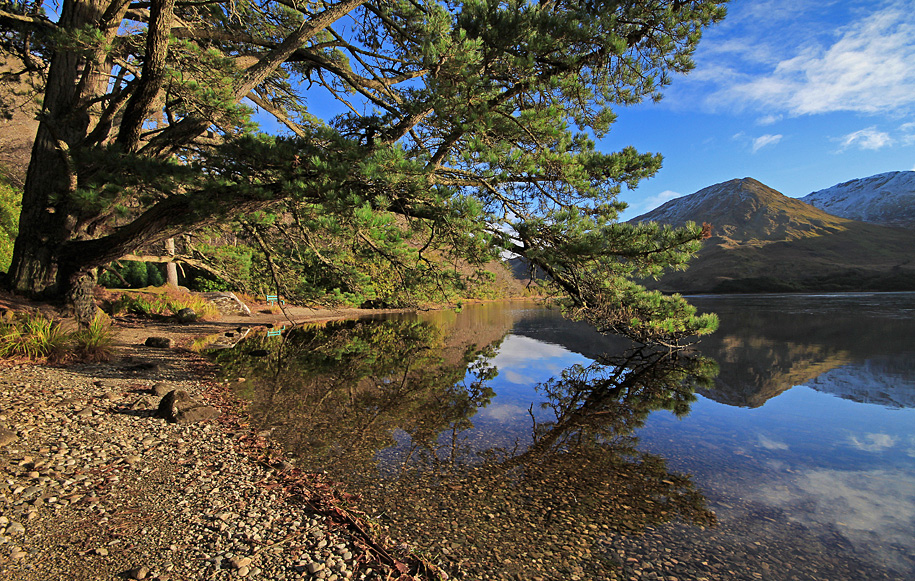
[601,0,915,219]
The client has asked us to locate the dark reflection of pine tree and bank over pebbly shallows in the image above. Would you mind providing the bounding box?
[219,320,717,579]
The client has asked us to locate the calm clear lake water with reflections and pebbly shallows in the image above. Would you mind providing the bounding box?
[219,293,915,581]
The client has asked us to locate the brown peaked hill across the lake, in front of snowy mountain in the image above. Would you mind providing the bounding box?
[632,178,915,293]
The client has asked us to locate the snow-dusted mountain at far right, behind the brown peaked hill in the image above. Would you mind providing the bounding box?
[801,171,915,228]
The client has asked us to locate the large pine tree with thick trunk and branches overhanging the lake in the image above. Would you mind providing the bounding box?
[0,0,724,339]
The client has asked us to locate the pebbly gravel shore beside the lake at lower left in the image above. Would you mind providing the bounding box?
[0,312,432,581]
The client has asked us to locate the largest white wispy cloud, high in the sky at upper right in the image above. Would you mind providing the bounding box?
[703,1,915,115]
